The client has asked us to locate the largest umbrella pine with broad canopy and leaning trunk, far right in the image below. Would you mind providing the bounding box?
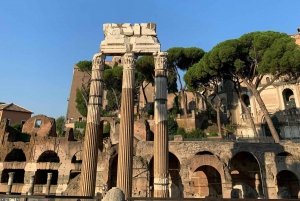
[185,31,300,142]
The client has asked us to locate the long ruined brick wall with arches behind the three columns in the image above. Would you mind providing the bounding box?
[0,115,300,198]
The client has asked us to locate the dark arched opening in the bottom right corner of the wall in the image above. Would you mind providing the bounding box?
[276,170,300,199]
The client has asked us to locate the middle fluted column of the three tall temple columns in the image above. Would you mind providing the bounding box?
[117,53,136,199]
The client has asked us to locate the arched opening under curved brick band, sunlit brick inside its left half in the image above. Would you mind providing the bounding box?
[191,165,222,198]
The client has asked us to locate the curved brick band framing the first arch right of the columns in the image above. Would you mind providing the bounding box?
[189,155,225,182]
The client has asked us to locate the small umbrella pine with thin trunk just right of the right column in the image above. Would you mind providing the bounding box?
[167,47,204,118]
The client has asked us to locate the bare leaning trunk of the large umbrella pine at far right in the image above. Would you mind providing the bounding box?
[242,79,280,143]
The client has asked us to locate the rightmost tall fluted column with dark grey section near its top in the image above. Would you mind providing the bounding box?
[154,52,169,197]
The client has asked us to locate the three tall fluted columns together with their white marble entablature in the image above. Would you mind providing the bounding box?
[81,23,169,198]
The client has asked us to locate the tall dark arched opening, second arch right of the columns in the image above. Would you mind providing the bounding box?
[229,152,262,199]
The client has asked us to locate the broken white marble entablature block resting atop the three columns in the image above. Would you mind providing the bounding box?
[100,23,160,55]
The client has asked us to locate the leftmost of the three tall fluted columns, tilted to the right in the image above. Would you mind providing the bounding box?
[80,53,105,196]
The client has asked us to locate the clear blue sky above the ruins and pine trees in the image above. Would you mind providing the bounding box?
[0,0,300,118]
